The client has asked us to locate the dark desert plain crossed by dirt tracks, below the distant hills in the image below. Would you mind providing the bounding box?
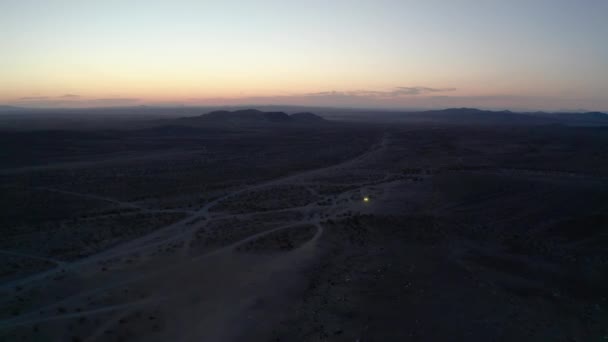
[0,114,608,341]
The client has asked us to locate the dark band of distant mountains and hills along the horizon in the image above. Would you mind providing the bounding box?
[0,105,608,127]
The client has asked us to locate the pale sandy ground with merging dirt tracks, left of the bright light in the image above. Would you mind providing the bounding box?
[0,136,390,341]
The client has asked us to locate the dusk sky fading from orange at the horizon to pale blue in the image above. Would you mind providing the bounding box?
[0,0,608,111]
